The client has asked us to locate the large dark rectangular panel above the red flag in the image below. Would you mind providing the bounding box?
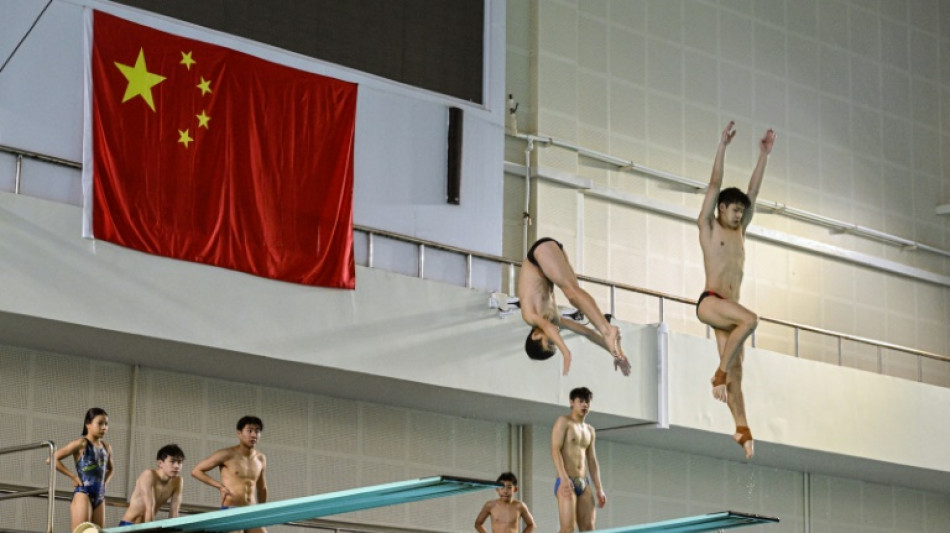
[116,0,485,103]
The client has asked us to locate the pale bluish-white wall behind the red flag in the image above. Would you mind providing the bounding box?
[0,0,505,254]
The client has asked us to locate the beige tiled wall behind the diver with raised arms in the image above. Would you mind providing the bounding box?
[505,0,950,374]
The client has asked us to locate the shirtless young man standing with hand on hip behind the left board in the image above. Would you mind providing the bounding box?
[191,416,267,533]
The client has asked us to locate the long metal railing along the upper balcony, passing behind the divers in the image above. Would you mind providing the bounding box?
[0,145,950,381]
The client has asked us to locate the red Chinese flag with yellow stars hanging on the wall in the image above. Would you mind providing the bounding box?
[86,12,357,289]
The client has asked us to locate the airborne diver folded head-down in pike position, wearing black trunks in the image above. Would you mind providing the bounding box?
[518,237,630,376]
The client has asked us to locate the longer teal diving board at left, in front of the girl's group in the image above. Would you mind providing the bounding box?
[103,476,501,533]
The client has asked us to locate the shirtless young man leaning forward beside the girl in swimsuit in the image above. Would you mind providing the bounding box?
[119,444,185,527]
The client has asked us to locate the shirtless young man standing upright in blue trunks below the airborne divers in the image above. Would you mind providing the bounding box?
[551,387,607,533]
